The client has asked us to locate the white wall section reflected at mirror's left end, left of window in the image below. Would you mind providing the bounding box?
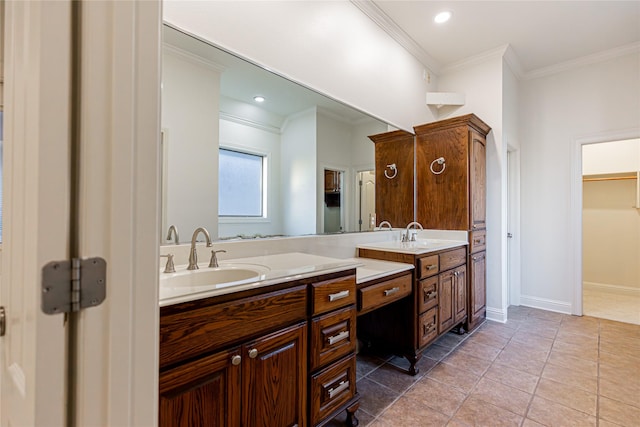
[162,48,220,240]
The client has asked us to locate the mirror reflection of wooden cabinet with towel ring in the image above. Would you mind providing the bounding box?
[369,130,414,227]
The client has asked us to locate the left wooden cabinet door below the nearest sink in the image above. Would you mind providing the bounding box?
[159,348,241,427]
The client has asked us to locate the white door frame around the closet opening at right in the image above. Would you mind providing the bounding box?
[569,128,640,316]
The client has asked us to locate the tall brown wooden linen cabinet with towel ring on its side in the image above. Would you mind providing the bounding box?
[414,114,491,330]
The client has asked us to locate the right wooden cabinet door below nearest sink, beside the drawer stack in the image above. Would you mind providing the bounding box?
[242,323,307,427]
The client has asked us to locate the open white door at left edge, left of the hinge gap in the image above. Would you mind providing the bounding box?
[0,1,71,426]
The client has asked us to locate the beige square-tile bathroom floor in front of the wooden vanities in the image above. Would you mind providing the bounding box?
[330,307,640,427]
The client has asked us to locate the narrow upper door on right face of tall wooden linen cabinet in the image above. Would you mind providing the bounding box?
[469,131,487,230]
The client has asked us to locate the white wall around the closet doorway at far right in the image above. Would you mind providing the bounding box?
[520,53,640,312]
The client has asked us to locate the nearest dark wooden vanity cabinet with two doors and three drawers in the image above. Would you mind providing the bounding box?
[159,269,359,427]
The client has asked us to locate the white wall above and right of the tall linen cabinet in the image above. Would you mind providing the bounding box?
[438,52,508,321]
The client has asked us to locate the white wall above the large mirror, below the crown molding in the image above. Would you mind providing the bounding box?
[163,0,435,131]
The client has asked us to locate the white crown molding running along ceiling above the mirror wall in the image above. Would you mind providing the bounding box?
[350,0,440,75]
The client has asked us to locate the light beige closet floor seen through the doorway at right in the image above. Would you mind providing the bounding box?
[582,286,640,325]
